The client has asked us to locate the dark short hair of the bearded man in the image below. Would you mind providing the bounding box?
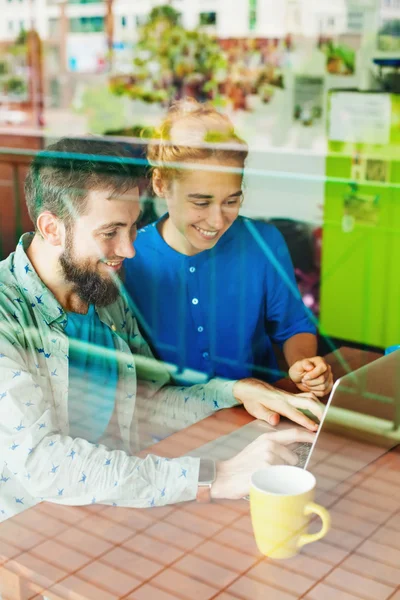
[25,138,144,228]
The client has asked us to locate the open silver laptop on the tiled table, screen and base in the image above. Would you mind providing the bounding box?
[188,351,400,480]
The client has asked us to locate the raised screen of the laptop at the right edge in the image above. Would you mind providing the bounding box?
[306,351,400,499]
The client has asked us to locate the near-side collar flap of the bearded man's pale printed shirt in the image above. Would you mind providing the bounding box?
[13,232,66,325]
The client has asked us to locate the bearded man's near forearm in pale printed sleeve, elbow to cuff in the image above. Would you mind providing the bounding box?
[26,436,199,508]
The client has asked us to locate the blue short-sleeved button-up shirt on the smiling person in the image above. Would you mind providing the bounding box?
[125,217,316,383]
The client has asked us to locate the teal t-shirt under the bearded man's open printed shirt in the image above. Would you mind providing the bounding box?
[65,304,118,443]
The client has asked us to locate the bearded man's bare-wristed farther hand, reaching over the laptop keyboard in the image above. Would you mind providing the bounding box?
[233,378,324,431]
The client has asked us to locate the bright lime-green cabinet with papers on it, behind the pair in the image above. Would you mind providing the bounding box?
[320,92,400,347]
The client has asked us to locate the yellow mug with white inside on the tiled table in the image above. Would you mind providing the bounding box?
[250,465,330,558]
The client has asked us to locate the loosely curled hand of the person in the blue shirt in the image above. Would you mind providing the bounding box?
[289,356,333,398]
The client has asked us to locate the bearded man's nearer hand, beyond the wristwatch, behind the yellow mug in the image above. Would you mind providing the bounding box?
[211,428,315,500]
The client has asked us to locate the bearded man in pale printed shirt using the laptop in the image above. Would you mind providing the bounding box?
[0,139,322,521]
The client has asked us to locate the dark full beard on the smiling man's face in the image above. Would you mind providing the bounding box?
[60,240,119,307]
